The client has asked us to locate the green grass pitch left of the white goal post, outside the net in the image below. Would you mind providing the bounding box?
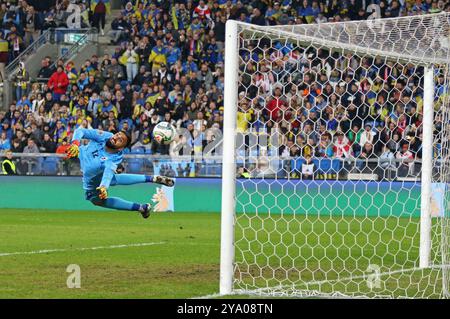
[0,209,220,298]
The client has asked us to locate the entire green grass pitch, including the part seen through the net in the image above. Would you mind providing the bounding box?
[0,209,440,298]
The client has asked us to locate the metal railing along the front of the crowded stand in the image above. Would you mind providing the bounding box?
[0,152,432,182]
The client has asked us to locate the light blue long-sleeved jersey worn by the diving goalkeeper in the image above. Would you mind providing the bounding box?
[72,129,123,190]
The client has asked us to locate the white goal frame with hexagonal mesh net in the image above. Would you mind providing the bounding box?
[220,13,450,298]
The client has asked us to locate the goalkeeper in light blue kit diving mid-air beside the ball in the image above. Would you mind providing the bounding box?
[67,129,174,218]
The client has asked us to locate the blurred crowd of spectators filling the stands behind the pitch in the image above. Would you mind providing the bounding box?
[0,0,450,176]
